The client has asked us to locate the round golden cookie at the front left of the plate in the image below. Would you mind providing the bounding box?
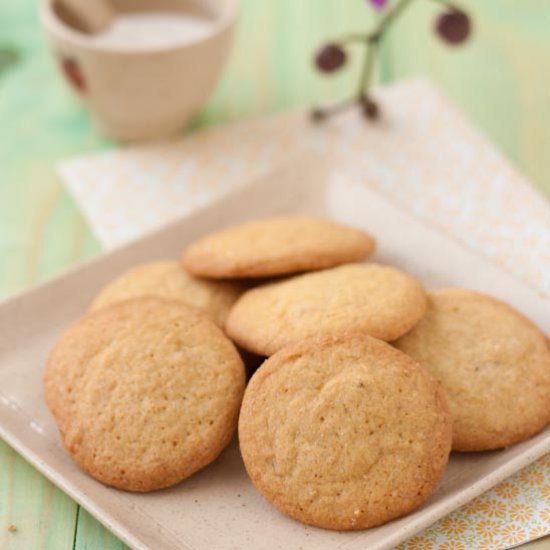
[44,298,245,492]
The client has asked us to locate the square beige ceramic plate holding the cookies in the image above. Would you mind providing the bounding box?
[0,159,550,550]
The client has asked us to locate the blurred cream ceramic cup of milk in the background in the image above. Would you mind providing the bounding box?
[41,0,238,141]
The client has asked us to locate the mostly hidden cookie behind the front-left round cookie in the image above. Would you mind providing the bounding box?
[90,261,243,327]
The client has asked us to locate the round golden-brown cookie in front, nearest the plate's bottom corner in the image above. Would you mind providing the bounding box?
[239,335,451,530]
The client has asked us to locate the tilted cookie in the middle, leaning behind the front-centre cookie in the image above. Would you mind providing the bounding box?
[226,263,426,356]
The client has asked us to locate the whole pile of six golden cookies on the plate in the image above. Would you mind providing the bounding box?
[44,218,550,529]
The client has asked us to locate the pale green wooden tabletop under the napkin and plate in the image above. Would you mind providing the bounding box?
[0,0,550,550]
